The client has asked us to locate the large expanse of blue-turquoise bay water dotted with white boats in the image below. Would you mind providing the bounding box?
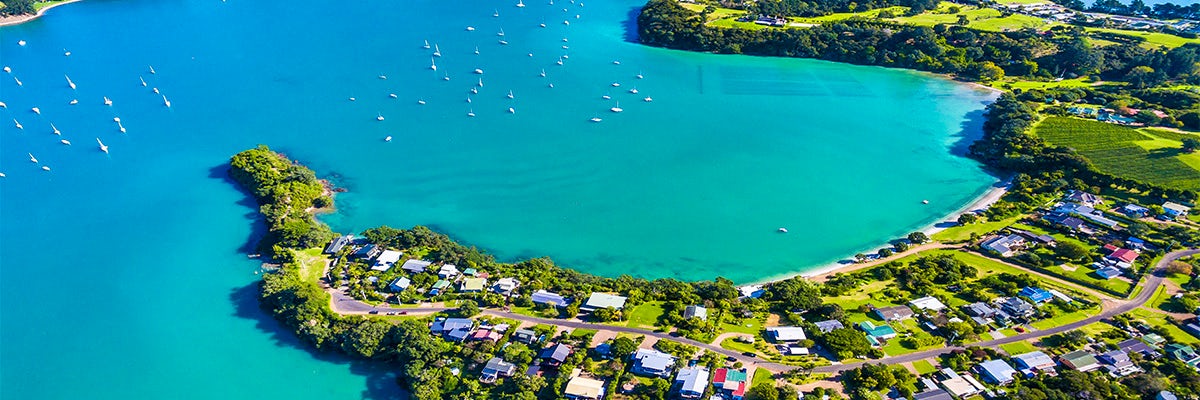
[0,0,995,400]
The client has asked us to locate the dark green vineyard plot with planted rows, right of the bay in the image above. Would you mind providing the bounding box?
[1034,117,1200,190]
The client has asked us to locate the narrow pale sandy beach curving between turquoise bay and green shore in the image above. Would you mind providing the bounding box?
[745,179,1013,285]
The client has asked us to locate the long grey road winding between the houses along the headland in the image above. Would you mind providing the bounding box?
[326,249,1200,374]
